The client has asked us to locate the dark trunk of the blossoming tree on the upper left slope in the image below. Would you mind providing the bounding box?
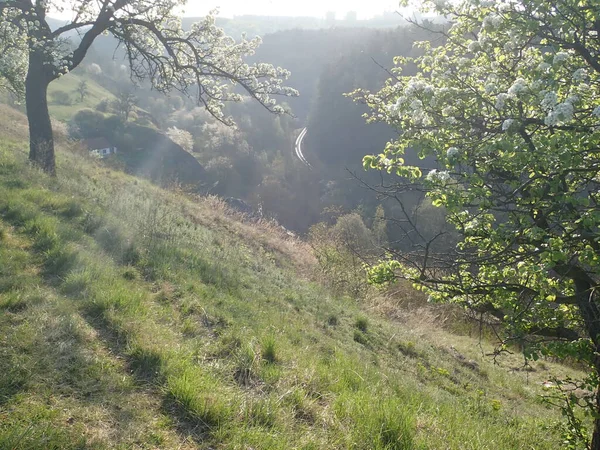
[25,52,56,176]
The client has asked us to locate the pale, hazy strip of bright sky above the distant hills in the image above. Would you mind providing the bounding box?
[185,0,399,19]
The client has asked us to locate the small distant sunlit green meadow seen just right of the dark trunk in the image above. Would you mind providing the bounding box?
[48,71,115,121]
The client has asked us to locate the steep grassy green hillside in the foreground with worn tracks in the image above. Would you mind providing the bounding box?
[0,104,584,450]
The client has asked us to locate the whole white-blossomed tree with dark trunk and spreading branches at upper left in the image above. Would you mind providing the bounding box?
[0,0,297,174]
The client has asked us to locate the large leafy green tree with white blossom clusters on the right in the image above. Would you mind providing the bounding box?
[355,0,600,450]
